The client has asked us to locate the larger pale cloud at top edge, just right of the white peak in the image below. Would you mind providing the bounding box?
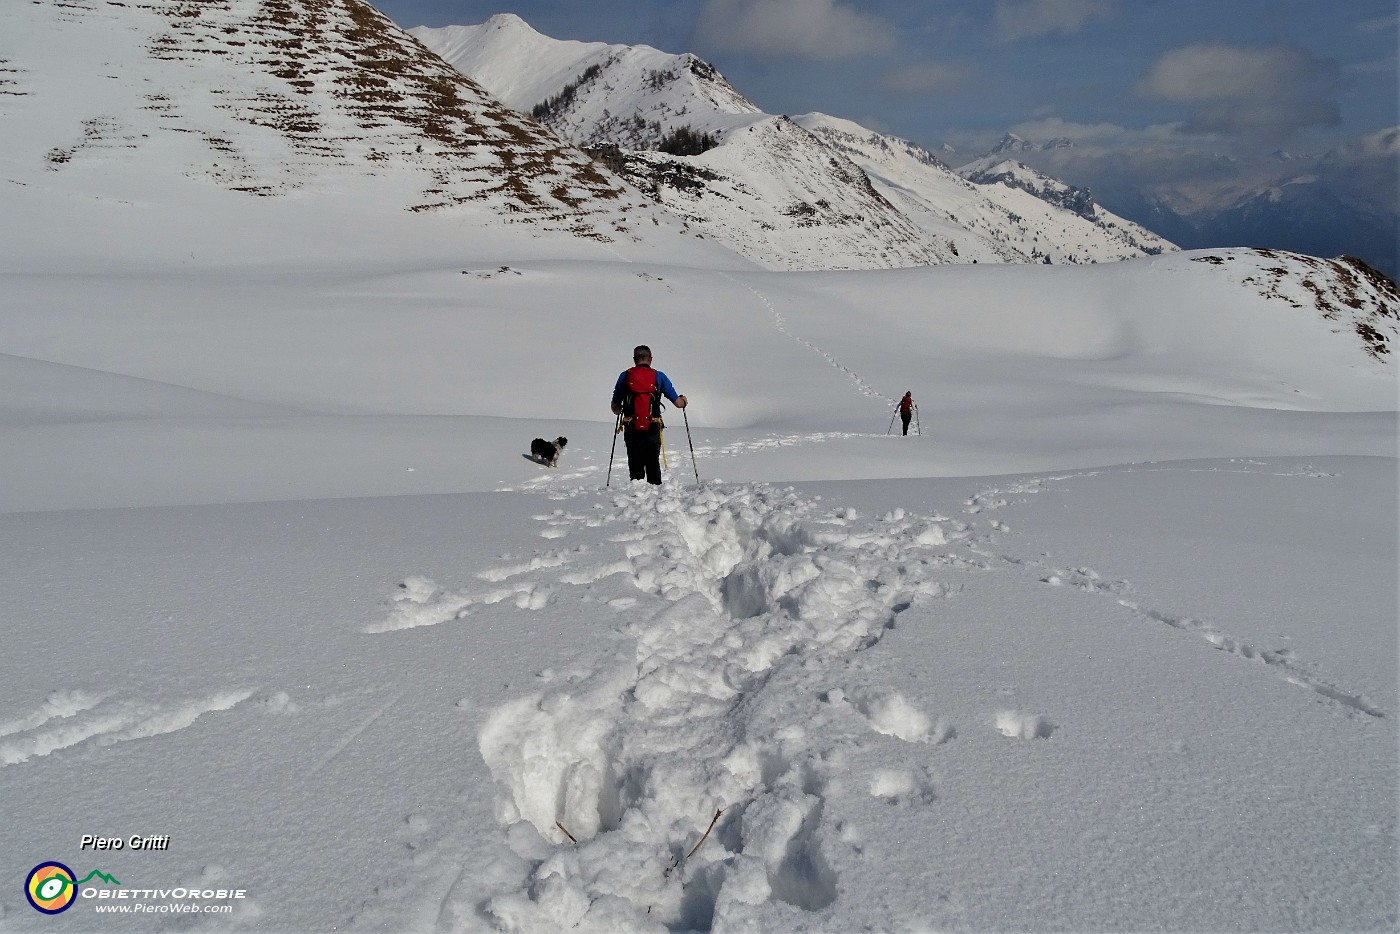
[696,0,896,62]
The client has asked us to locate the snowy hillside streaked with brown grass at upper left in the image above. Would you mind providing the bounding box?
[0,0,739,268]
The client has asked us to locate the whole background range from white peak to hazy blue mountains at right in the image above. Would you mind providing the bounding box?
[410,14,1400,276]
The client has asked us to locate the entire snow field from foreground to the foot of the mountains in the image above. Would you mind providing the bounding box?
[0,179,1400,931]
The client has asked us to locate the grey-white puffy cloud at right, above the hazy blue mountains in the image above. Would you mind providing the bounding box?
[1138,42,1340,143]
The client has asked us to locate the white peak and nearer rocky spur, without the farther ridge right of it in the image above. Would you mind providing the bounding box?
[409,14,958,269]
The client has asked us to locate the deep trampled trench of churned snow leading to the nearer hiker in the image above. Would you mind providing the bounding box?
[364,468,1389,931]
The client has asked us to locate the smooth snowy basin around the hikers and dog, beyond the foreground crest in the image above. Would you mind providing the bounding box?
[0,245,1400,510]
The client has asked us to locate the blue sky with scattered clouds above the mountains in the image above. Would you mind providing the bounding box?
[375,0,1400,157]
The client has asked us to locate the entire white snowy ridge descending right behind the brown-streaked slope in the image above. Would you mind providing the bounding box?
[410,14,1172,269]
